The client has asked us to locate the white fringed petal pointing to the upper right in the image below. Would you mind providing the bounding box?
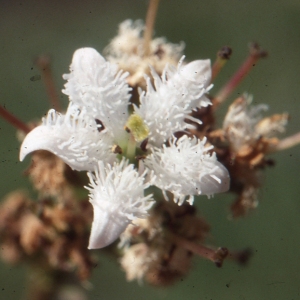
[134,60,211,146]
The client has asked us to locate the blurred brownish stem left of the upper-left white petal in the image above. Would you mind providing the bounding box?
[36,55,61,111]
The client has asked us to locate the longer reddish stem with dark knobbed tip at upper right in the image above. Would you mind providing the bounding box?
[213,44,267,109]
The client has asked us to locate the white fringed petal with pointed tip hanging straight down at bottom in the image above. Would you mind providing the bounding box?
[86,159,154,249]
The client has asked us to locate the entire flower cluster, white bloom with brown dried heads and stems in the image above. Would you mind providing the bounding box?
[0,0,300,292]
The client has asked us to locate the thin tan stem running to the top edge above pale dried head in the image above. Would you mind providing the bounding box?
[144,0,160,56]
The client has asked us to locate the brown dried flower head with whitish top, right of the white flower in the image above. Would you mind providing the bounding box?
[216,95,288,217]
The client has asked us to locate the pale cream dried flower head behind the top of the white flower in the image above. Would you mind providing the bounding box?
[104,20,185,87]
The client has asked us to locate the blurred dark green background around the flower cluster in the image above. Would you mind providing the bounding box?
[0,0,300,300]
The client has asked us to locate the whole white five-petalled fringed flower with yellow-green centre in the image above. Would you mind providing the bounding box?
[20,48,229,249]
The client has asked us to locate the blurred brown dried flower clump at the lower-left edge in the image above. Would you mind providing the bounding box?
[0,192,95,281]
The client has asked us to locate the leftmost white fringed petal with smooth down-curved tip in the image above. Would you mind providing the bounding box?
[20,105,116,171]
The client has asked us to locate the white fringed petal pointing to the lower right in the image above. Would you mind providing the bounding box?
[145,136,230,205]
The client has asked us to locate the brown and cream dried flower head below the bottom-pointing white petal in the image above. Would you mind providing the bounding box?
[119,201,209,286]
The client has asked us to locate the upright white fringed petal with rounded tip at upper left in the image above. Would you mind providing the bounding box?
[63,48,131,140]
